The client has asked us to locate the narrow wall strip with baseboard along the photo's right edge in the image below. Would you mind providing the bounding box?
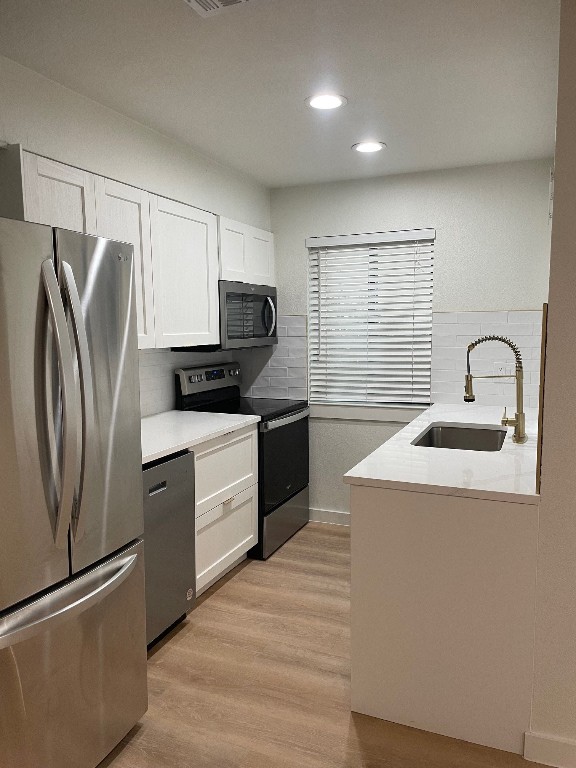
[526,0,576,766]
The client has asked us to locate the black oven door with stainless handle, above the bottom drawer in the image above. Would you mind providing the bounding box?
[258,408,310,515]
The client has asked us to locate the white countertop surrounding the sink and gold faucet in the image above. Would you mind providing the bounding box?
[344,403,540,504]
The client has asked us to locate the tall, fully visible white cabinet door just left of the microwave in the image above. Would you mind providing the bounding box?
[150,195,220,347]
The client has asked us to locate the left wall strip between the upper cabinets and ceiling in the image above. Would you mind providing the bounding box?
[0,57,270,229]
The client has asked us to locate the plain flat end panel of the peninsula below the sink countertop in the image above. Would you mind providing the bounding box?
[351,485,538,753]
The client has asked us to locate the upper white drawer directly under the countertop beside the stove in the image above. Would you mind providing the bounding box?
[194,426,258,517]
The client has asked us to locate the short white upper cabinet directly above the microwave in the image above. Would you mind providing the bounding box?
[220,217,276,286]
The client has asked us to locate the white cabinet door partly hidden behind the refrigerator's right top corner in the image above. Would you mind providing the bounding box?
[96,176,155,349]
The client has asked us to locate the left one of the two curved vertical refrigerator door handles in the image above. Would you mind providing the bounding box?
[42,259,78,549]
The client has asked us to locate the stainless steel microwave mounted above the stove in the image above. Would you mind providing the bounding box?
[220,280,278,349]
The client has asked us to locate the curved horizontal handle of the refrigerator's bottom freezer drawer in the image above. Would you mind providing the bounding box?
[0,554,138,650]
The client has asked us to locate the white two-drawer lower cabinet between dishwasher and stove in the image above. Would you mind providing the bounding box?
[194,425,258,592]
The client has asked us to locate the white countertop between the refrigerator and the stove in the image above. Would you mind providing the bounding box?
[142,411,260,464]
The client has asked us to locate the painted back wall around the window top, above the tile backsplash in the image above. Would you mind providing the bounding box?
[272,159,551,314]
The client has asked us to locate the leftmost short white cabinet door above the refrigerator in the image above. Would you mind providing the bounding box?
[23,152,96,235]
